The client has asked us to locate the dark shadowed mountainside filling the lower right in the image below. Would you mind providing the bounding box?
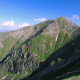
[23,36,80,80]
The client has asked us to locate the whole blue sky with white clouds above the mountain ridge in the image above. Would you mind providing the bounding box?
[0,0,80,32]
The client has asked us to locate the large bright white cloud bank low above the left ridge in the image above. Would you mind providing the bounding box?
[0,20,29,32]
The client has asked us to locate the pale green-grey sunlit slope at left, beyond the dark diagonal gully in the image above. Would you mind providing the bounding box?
[0,25,44,60]
